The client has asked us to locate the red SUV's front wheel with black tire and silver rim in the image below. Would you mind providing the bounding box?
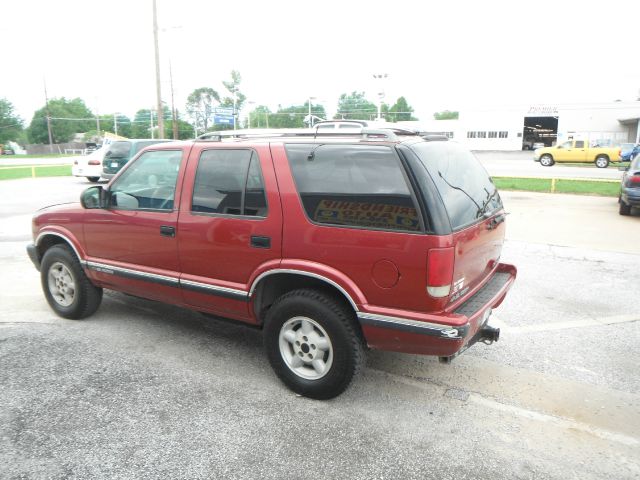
[40,245,102,320]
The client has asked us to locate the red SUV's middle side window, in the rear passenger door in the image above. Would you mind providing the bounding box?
[191,149,267,217]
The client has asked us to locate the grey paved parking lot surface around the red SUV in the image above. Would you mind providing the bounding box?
[0,178,640,479]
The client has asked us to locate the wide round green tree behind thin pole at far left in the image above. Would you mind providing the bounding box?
[28,97,96,143]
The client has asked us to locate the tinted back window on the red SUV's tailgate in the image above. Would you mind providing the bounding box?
[410,142,502,230]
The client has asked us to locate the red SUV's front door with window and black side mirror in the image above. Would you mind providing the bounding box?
[84,149,185,303]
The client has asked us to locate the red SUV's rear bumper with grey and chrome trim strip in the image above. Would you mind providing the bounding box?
[358,263,517,357]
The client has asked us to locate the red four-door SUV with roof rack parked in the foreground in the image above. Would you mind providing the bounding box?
[27,130,516,399]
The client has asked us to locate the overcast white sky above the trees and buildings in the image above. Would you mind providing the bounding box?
[0,0,640,125]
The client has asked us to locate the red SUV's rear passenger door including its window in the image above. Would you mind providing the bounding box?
[178,144,282,320]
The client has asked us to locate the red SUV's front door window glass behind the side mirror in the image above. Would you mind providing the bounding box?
[109,150,182,210]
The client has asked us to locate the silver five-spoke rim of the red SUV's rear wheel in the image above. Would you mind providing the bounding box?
[278,317,333,380]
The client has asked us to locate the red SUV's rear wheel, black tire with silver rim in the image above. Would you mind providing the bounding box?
[264,289,365,400]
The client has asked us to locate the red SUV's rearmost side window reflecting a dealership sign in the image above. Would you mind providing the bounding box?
[286,144,422,232]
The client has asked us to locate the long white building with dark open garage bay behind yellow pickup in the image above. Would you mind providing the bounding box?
[400,101,640,150]
